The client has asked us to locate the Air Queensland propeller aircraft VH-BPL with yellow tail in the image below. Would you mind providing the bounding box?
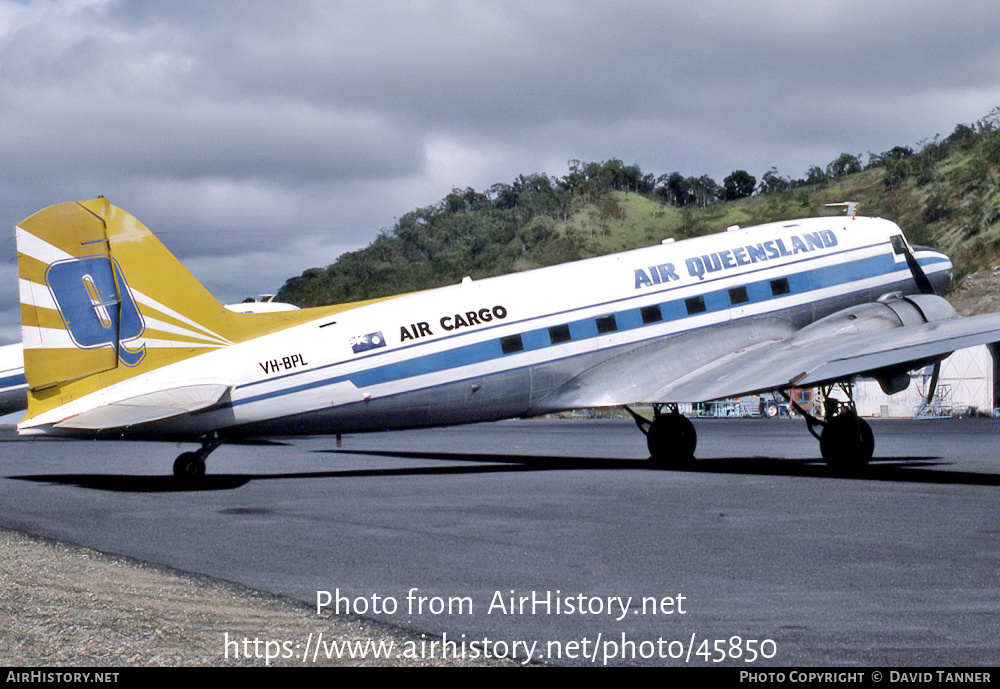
[11,198,1000,479]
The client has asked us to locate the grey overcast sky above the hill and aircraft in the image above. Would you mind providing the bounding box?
[0,0,1000,342]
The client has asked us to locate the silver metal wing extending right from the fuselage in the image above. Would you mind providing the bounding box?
[545,313,1000,407]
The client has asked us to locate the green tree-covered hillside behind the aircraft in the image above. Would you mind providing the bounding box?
[278,108,1000,306]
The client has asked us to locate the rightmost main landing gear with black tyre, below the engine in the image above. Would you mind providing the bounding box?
[783,383,875,472]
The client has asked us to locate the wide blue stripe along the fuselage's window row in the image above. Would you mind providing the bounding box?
[233,247,912,406]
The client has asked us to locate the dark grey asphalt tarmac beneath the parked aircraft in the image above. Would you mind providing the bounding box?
[0,419,1000,669]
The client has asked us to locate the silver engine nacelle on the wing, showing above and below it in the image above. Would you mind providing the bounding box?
[789,294,958,395]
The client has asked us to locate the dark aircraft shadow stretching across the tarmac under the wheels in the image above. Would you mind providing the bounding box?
[7,450,1000,493]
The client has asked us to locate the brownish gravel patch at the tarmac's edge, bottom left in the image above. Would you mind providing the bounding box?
[0,530,511,667]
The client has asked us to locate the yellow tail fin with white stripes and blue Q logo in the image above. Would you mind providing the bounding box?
[16,198,310,419]
